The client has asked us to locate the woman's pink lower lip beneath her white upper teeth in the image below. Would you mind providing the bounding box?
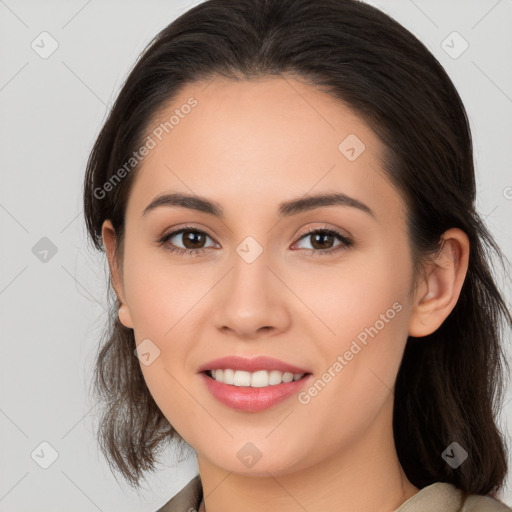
[201,373,313,412]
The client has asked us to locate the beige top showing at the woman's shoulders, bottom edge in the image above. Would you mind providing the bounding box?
[157,475,512,512]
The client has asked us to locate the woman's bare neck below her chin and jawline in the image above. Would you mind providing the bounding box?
[197,403,419,512]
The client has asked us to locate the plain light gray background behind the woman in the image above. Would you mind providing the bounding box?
[0,0,512,512]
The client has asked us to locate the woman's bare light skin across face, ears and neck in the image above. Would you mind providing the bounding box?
[103,77,469,512]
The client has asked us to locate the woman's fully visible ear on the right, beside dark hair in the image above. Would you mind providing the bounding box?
[409,228,469,337]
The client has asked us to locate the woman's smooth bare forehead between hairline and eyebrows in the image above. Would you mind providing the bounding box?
[129,77,403,224]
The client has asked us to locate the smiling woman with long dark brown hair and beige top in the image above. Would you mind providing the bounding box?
[84,0,512,512]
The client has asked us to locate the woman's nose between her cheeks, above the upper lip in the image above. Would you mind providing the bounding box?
[213,251,292,339]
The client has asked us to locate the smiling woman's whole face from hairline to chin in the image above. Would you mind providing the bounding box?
[105,78,420,475]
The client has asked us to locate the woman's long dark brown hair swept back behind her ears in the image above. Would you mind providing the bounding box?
[84,0,512,496]
